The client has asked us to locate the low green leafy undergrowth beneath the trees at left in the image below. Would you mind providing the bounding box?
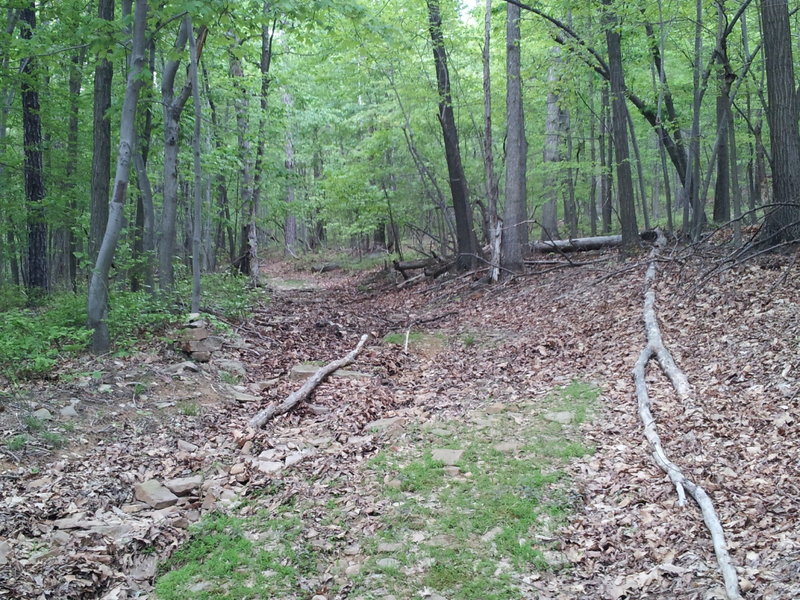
[0,274,257,380]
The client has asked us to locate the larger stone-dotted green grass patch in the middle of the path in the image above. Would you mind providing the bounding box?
[353,381,599,600]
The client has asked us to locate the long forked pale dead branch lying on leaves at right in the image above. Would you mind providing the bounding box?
[633,232,741,600]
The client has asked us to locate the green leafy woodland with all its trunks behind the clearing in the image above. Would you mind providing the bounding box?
[0,0,800,350]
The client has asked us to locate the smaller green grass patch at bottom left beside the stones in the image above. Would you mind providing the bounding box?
[155,514,317,600]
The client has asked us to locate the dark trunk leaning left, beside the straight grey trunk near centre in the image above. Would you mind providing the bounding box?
[426,0,476,270]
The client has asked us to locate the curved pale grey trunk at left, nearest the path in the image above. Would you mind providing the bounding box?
[87,0,148,353]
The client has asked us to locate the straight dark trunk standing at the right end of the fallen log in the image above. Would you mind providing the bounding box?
[603,0,638,250]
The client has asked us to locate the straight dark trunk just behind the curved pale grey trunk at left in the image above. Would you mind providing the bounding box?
[89,0,114,262]
